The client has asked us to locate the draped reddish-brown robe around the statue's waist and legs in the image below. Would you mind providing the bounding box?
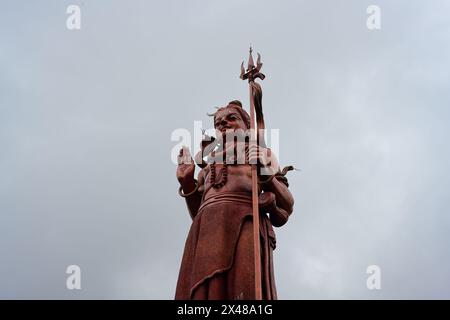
[175,192,277,300]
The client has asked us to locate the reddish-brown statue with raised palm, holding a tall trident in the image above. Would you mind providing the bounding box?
[175,51,294,300]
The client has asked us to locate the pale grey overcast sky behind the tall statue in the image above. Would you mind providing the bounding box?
[0,0,450,299]
